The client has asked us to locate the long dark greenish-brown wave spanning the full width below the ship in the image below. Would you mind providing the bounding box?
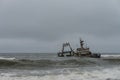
[0,58,120,68]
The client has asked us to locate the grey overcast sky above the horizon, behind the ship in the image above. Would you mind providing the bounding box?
[0,0,120,53]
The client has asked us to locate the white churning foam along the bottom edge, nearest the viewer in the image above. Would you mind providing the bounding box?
[0,67,120,80]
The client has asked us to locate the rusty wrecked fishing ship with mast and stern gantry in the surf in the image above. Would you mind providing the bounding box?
[58,39,101,58]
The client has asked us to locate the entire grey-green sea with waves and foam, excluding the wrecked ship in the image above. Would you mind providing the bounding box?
[0,53,120,80]
